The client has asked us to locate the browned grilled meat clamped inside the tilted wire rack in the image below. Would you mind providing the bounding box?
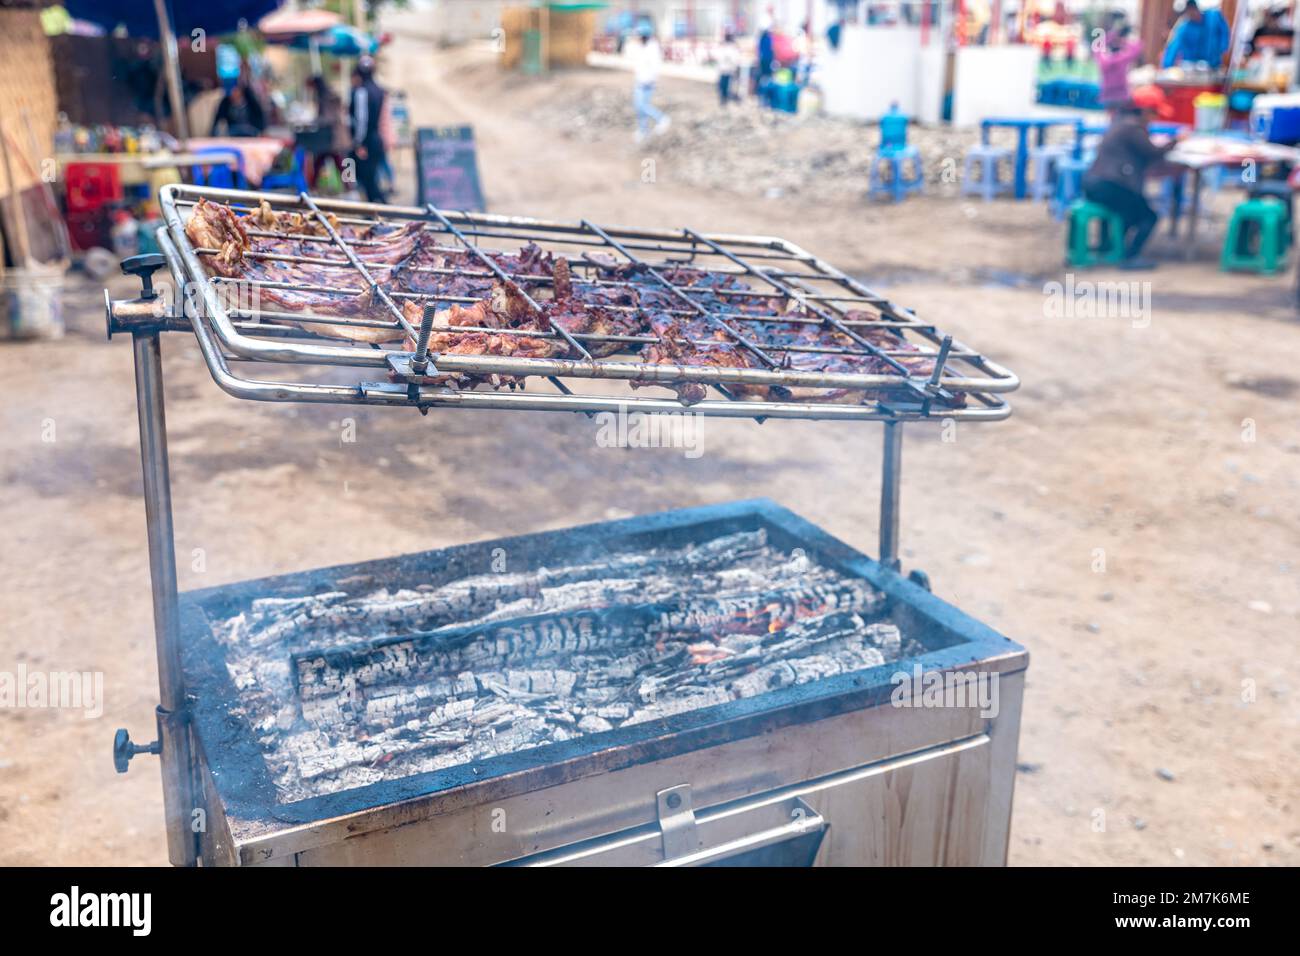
[186,199,965,406]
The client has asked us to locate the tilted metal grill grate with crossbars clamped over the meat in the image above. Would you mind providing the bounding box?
[161,186,1019,421]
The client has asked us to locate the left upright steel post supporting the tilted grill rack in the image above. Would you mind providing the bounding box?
[131,332,198,866]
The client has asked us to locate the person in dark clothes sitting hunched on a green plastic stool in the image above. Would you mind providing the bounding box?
[1083,86,1174,269]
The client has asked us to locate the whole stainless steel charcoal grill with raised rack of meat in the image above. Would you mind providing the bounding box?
[105,186,1027,865]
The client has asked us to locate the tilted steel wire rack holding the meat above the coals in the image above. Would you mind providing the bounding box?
[159,185,1019,421]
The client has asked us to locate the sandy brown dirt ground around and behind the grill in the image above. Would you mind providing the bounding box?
[0,36,1300,865]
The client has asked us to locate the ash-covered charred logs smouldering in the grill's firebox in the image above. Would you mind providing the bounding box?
[205,531,911,801]
